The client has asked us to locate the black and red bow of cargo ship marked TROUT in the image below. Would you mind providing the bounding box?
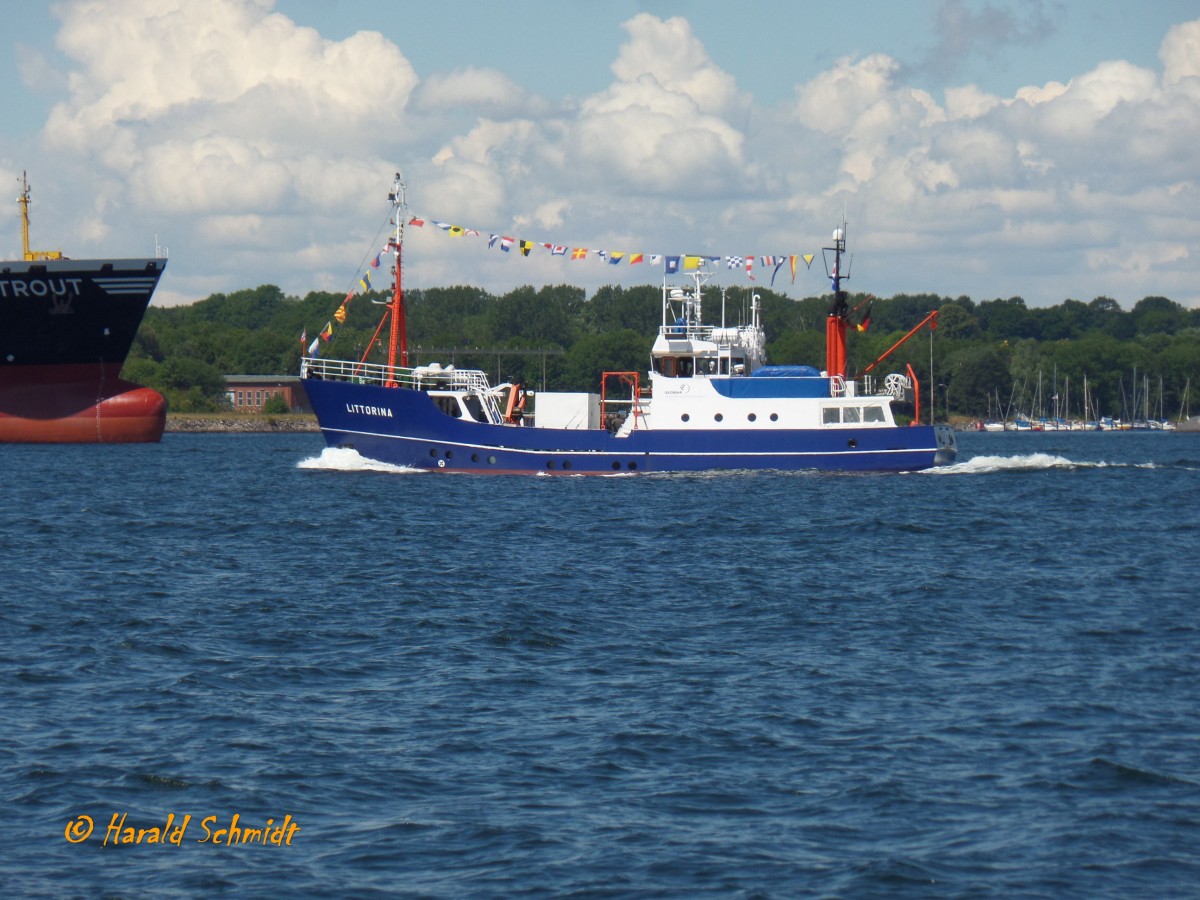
[0,259,167,444]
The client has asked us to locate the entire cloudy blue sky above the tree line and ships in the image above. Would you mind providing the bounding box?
[0,0,1200,310]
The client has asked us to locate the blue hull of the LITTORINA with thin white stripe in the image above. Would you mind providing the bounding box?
[304,379,954,475]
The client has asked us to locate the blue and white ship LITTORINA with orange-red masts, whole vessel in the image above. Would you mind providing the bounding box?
[301,176,956,475]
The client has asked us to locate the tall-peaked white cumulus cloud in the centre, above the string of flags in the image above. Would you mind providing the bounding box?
[418,13,756,241]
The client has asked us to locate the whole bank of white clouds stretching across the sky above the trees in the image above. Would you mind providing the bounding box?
[16,0,1200,302]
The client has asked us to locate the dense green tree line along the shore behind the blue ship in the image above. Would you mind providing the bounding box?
[124,284,1200,418]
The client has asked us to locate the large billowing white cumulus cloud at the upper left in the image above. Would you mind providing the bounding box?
[44,0,416,214]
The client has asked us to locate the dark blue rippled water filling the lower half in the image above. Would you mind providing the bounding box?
[0,434,1200,898]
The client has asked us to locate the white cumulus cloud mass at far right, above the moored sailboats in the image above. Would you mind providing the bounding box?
[768,14,1200,302]
